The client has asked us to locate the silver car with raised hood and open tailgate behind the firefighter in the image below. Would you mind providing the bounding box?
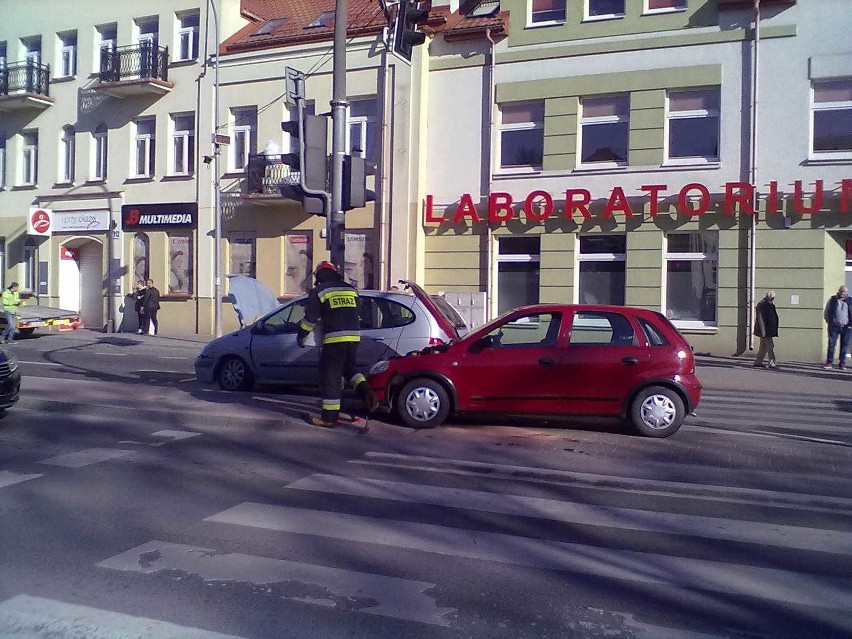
[195,281,466,390]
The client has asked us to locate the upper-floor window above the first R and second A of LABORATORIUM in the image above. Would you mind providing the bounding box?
[580,95,630,165]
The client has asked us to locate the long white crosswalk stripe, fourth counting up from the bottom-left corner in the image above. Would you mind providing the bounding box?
[287,474,852,555]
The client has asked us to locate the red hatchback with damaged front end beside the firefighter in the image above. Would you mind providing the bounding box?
[369,304,701,437]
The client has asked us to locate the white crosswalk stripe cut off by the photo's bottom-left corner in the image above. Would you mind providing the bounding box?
[0,595,246,639]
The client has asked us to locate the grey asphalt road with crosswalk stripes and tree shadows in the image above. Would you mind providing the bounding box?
[0,331,852,639]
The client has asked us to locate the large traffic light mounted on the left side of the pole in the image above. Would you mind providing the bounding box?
[280,114,329,216]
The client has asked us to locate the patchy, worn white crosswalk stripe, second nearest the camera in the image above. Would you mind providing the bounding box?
[98,540,456,626]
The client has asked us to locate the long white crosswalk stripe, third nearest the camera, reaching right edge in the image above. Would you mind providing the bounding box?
[205,502,852,614]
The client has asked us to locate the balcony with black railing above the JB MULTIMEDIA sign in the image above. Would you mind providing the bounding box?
[93,42,175,98]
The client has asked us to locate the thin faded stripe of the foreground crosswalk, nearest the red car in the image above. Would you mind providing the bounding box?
[349,452,852,514]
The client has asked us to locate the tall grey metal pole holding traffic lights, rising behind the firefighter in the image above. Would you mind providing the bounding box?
[327,0,349,273]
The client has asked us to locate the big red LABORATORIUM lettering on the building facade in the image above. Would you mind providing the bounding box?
[424,179,852,224]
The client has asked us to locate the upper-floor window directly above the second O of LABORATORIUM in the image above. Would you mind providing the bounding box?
[666,88,719,162]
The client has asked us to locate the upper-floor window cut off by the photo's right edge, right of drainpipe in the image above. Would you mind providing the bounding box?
[811,78,852,159]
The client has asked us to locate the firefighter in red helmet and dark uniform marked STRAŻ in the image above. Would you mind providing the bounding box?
[296,262,379,428]
